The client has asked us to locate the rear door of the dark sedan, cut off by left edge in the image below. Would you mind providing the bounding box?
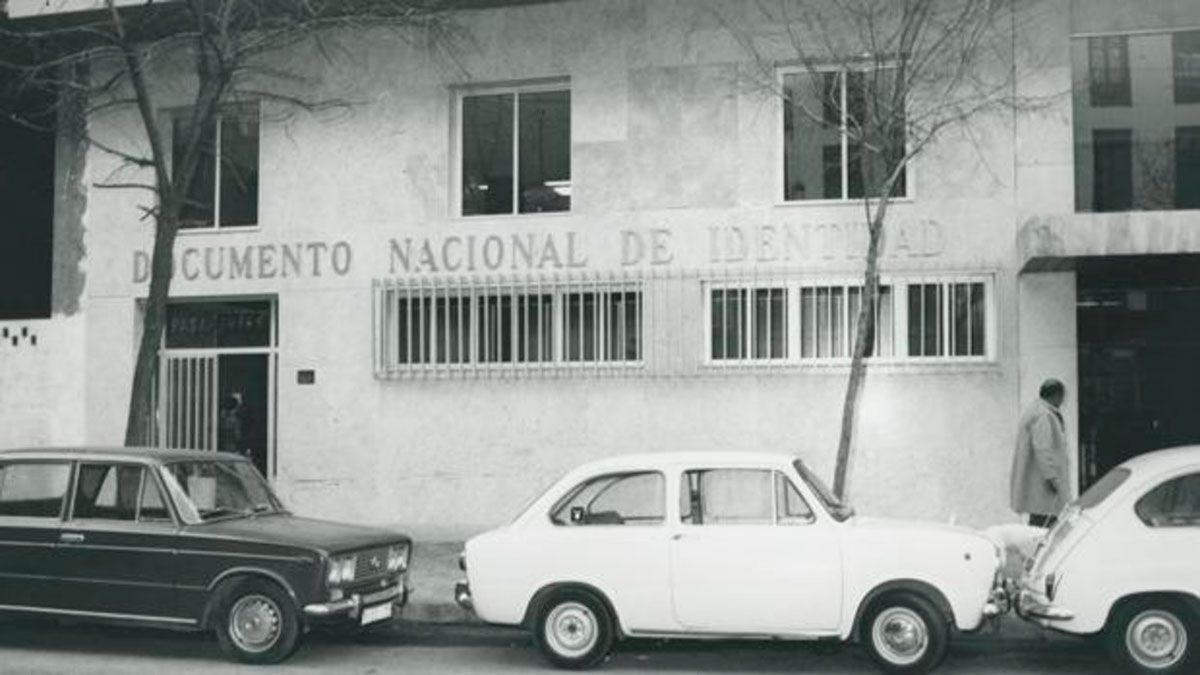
[0,460,71,609]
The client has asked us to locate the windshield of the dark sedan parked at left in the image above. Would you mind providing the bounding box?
[167,460,283,522]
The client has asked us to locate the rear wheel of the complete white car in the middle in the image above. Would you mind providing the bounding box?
[533,589,614,670]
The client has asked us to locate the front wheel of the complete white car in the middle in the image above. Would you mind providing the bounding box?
[859,592,950,673]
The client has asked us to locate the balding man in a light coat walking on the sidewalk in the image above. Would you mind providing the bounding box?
[1010,380,1070,527]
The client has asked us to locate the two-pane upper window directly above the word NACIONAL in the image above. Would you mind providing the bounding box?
[458,85,571,216]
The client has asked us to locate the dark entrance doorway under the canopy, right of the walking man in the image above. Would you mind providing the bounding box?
[1076,255,1200,488]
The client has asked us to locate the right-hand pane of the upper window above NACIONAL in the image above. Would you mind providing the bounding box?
[517,91,571,214]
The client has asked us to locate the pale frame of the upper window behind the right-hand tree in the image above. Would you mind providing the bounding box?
[774,64,918,207]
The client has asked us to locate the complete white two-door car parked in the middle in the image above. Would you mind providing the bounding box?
[456,453,1006,673]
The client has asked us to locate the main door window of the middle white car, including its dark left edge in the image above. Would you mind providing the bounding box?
[679,468,775,525]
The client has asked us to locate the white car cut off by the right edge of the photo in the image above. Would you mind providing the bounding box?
[1016,446,1200,673]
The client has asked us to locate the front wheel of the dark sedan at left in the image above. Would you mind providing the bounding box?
[215,578,300,664]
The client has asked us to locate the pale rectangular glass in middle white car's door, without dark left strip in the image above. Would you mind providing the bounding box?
[697,468,775,525]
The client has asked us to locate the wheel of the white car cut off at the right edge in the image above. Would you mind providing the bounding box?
[1105,599,1198,674]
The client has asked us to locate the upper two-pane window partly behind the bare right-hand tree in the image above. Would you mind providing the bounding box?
[782,68,907,201]
